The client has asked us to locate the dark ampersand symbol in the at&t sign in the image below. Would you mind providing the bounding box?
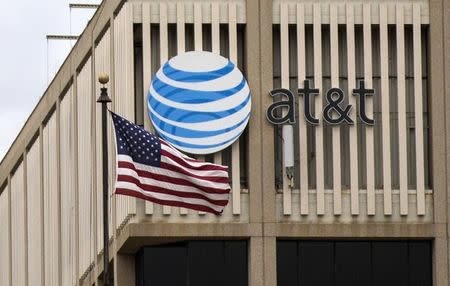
[323,88,354,124]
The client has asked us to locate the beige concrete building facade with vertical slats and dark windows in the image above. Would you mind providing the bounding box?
[0,0,450,286]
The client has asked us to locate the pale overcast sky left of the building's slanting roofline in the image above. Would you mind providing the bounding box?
[0,0,101,160]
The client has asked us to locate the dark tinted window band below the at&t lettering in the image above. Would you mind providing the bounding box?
[277,241,432,286]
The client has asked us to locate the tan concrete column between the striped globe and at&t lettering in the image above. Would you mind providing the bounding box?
[246,0,276,286]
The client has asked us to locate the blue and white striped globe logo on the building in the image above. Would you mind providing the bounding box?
[148,51,251,154]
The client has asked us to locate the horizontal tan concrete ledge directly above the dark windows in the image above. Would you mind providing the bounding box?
[113,223,446,255]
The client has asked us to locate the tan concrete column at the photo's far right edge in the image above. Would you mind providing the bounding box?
[429,0,450,285]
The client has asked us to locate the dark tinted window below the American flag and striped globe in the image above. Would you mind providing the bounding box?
[136,241,248,286]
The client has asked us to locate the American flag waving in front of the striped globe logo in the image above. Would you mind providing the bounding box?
[111,112,230,214]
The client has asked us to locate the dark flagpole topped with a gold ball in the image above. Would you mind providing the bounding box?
[97,74,111,286]
